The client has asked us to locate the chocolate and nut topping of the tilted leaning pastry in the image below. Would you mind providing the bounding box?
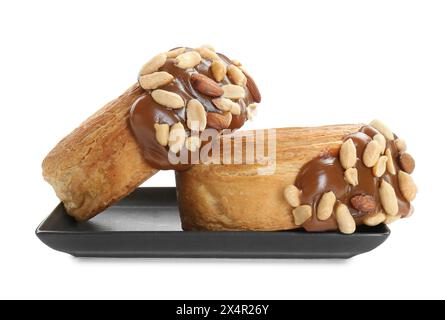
[130,47,261,170]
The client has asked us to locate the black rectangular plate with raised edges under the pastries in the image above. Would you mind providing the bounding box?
[36,188,390,259]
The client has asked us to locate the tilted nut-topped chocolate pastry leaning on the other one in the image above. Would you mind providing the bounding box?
[42,46,261,221]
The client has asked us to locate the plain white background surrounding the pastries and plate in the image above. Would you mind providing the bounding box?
[0,0,445,299]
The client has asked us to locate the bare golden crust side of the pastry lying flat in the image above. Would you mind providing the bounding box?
[176,124,361,231]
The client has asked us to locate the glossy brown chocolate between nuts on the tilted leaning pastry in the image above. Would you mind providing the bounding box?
[130,48,255,170]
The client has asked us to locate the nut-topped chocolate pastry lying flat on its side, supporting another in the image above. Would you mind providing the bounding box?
[176,121,417,234]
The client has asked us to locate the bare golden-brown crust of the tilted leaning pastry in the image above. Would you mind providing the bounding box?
[42,84,158,220]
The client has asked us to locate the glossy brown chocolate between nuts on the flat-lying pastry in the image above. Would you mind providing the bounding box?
[295,126,411,231]
